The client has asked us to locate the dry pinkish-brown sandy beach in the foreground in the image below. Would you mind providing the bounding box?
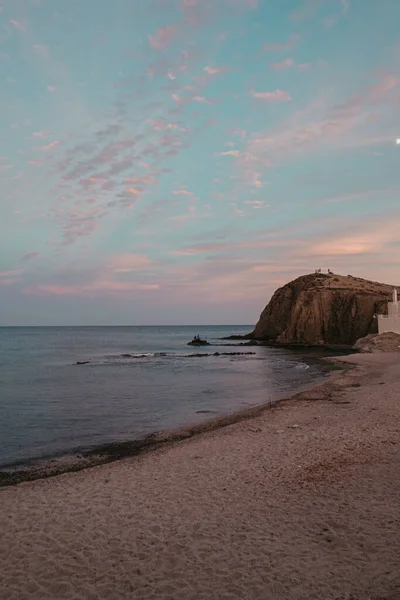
[0,354,400,600]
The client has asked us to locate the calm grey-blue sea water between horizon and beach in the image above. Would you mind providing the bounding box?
[0,326,334,466]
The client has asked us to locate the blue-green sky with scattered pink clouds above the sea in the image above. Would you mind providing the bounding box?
[0,0,400,326]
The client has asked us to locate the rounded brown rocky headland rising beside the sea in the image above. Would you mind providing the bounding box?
[250,273,393,345]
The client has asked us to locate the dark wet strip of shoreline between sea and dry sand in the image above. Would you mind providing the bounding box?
[0,353,350,489]
